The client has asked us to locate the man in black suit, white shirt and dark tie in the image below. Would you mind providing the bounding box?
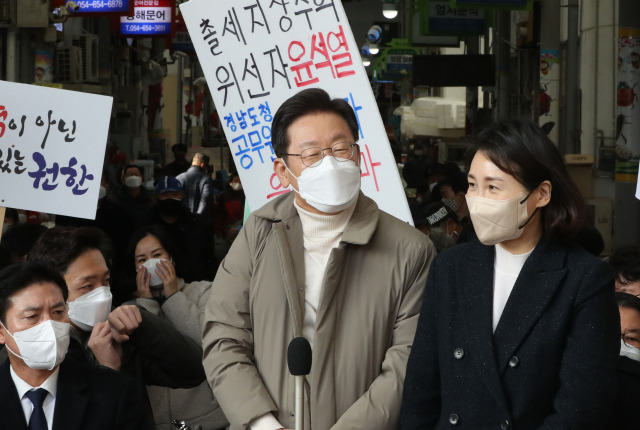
[0,262,150,430]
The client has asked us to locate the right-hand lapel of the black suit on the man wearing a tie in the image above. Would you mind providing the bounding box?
[53,359,89,430]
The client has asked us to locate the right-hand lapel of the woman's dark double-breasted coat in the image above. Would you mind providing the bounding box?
[494,239,567,373]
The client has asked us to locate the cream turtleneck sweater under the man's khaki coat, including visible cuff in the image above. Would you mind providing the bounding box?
[249,200,356,430]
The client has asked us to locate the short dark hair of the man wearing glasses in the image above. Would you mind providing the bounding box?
[271,88,359,158]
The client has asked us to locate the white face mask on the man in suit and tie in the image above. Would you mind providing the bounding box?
[0,320,70,370]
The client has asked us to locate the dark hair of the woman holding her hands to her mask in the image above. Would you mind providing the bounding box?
[118,225,189,304]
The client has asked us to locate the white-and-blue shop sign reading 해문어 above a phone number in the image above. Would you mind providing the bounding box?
[120,0,174,37]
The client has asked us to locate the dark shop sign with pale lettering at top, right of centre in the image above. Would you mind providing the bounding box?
[423,0,485,34]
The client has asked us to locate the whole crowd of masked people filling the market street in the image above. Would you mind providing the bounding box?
[0,89,640,430]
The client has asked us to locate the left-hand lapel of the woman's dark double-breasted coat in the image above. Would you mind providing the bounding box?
[456,241,509,413]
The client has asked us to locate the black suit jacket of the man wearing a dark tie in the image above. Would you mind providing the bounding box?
[0,359,153,430]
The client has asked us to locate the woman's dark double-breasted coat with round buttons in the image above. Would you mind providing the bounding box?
[401,239,620,430]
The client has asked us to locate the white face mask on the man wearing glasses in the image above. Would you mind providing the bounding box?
[285,156,360,213]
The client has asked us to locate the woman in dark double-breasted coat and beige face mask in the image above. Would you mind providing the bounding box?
[401,121,620,430]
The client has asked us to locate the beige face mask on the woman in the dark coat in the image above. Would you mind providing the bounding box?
[467,192,535,245]
